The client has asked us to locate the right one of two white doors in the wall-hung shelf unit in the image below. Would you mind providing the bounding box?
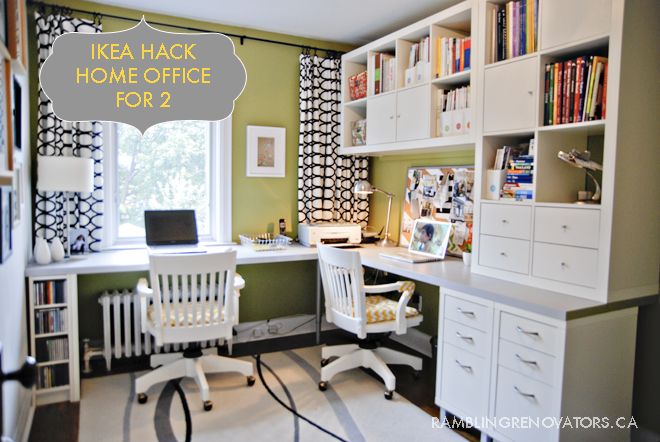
[396,86,431,141]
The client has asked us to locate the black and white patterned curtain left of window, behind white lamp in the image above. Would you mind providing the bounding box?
[34,9,103,251]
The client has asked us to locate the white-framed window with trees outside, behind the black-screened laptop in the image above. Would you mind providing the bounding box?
[104,118,231,246]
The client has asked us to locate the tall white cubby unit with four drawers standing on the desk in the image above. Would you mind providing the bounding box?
[472,0,660,302]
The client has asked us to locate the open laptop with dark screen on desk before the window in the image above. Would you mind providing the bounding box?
[144,210,206,255]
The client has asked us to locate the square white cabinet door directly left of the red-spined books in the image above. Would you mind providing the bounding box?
[484,58,538,132]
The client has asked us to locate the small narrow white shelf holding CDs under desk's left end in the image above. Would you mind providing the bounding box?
[28,275,80,405]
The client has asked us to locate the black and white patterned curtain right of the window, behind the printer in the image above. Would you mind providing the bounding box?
[298,53,369,226]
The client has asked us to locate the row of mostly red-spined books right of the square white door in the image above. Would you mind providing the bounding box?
[543,55,607,126]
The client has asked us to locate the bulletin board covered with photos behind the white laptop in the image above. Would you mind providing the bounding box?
[399,166,474,257]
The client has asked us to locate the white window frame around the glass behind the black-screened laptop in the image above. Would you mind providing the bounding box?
[102,116,232,249]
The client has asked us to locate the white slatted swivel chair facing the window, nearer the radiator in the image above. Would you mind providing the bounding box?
[135,251,255,411]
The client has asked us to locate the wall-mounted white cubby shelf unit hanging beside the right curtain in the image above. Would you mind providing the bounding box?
[340,0,478,155]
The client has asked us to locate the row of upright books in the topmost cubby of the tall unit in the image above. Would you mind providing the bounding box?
[486,0,539,62]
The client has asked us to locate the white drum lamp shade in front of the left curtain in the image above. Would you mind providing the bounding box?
[37,155,94,192]
